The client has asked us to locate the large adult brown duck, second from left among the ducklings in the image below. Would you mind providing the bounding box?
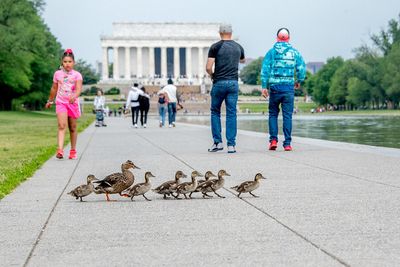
[94,160,140,201]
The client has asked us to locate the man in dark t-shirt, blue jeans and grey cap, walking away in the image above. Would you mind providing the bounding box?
[206,24,245,153]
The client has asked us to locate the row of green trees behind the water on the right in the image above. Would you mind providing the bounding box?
[240,15,400,109]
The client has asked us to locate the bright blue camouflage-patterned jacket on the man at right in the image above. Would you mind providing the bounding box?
[261,42,306,90]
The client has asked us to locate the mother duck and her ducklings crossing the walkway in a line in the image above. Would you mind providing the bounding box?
[68,160,266,201]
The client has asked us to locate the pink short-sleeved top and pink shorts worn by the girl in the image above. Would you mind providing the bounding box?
[53,70,82,119]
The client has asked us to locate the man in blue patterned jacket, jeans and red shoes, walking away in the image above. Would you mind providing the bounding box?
[261,28,306,151]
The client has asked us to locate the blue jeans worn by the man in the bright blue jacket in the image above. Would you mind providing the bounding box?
[268,89,294,146]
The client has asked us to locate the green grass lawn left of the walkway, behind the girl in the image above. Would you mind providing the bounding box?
[0,108,95,199]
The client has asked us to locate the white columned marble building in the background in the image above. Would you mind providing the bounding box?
[101,22,220,85]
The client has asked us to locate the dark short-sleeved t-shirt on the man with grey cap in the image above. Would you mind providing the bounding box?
[208,40,244,82]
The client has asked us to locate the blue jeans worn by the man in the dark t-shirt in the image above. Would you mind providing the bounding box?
[211,80,239,146]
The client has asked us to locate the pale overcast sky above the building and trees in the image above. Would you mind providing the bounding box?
[43,0,400,64]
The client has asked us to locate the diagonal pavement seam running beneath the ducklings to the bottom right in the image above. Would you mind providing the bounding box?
[136,133,350,267]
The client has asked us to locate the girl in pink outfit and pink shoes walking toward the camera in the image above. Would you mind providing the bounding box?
[46,49,82,159]
